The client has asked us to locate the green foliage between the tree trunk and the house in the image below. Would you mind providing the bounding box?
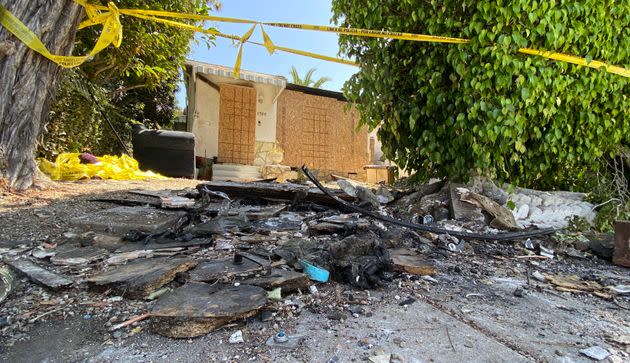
[37,0,220,159]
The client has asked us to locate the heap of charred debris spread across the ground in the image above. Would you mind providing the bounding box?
[0,167,630,358]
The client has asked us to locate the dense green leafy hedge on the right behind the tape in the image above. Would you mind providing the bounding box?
[332,0,630,189]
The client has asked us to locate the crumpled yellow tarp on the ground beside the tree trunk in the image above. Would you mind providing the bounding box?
[37,153,166,180]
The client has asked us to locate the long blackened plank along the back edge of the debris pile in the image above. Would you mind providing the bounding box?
[198,181,354,206]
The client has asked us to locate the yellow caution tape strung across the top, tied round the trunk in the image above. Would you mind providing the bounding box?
[0,0,630,77]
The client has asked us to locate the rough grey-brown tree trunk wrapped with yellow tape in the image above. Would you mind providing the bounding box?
[0,0,82,190]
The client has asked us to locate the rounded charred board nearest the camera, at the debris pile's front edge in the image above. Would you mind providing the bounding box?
[151,282,267,338]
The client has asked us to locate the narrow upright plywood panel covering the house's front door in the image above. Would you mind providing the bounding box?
[218,84,256,165]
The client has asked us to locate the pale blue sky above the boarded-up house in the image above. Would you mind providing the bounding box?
[177,0,358,105]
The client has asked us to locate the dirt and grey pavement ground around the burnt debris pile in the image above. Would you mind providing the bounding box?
[0,179,630,362]
